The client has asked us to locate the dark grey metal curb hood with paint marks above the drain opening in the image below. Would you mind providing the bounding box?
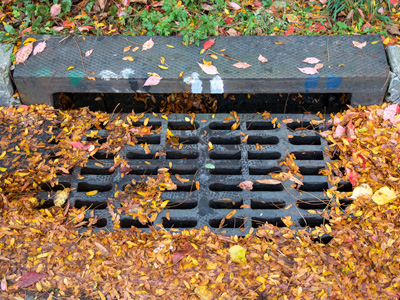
[14,35,389,105]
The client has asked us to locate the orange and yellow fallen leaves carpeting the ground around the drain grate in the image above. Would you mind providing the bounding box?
[0,104,400,300]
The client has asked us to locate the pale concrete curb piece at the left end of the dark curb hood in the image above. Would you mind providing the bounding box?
[0,44,19,106]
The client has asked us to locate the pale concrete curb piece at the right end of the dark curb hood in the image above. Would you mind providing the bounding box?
[386,46,400,104]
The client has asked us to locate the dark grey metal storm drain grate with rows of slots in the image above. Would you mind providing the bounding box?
[38,114,351,235]
